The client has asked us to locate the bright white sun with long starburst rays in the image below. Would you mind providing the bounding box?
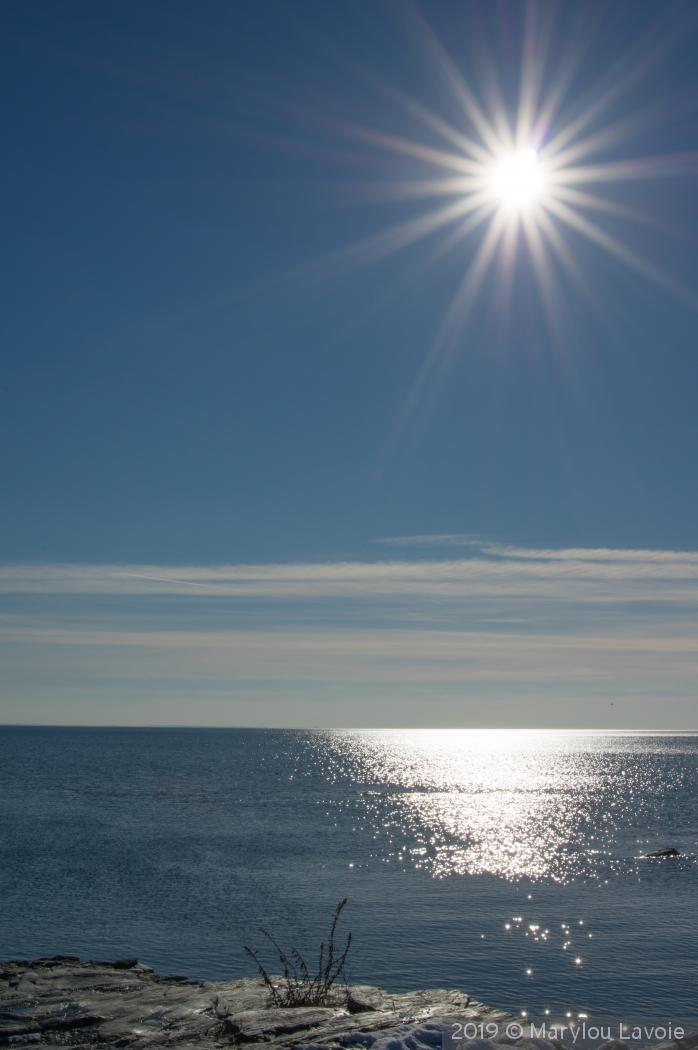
[277,0,698,445]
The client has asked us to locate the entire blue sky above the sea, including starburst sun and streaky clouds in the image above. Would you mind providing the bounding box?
[0,0,698,729]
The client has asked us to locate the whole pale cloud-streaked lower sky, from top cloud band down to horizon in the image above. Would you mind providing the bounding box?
[0,544,698,729]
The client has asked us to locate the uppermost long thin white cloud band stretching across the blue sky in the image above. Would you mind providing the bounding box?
[0,544,698,602]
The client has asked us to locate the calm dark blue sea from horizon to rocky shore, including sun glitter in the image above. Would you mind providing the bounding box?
[0,727,698,1016]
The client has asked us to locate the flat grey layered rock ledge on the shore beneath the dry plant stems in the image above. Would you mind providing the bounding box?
[0,956,509,1050]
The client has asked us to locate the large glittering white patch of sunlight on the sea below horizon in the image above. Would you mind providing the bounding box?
[312,730,682,882]
